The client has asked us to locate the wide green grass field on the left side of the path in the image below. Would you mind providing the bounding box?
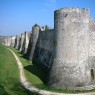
[0,44,38,95]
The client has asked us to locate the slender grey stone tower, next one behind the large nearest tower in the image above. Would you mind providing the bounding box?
[29,26,40,60]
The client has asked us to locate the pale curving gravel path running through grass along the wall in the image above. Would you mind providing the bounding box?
[9,49,95,95]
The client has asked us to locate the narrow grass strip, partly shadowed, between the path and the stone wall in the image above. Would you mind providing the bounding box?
[11,48,95,93]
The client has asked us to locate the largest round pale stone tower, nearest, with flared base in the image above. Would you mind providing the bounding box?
[48,8,91,89]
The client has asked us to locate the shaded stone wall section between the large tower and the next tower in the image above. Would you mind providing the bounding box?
[33,30,54,68]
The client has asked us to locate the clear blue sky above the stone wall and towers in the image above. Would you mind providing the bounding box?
[0,0,95,36]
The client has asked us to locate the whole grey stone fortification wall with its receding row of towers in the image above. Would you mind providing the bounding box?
[2,8,95,89]
